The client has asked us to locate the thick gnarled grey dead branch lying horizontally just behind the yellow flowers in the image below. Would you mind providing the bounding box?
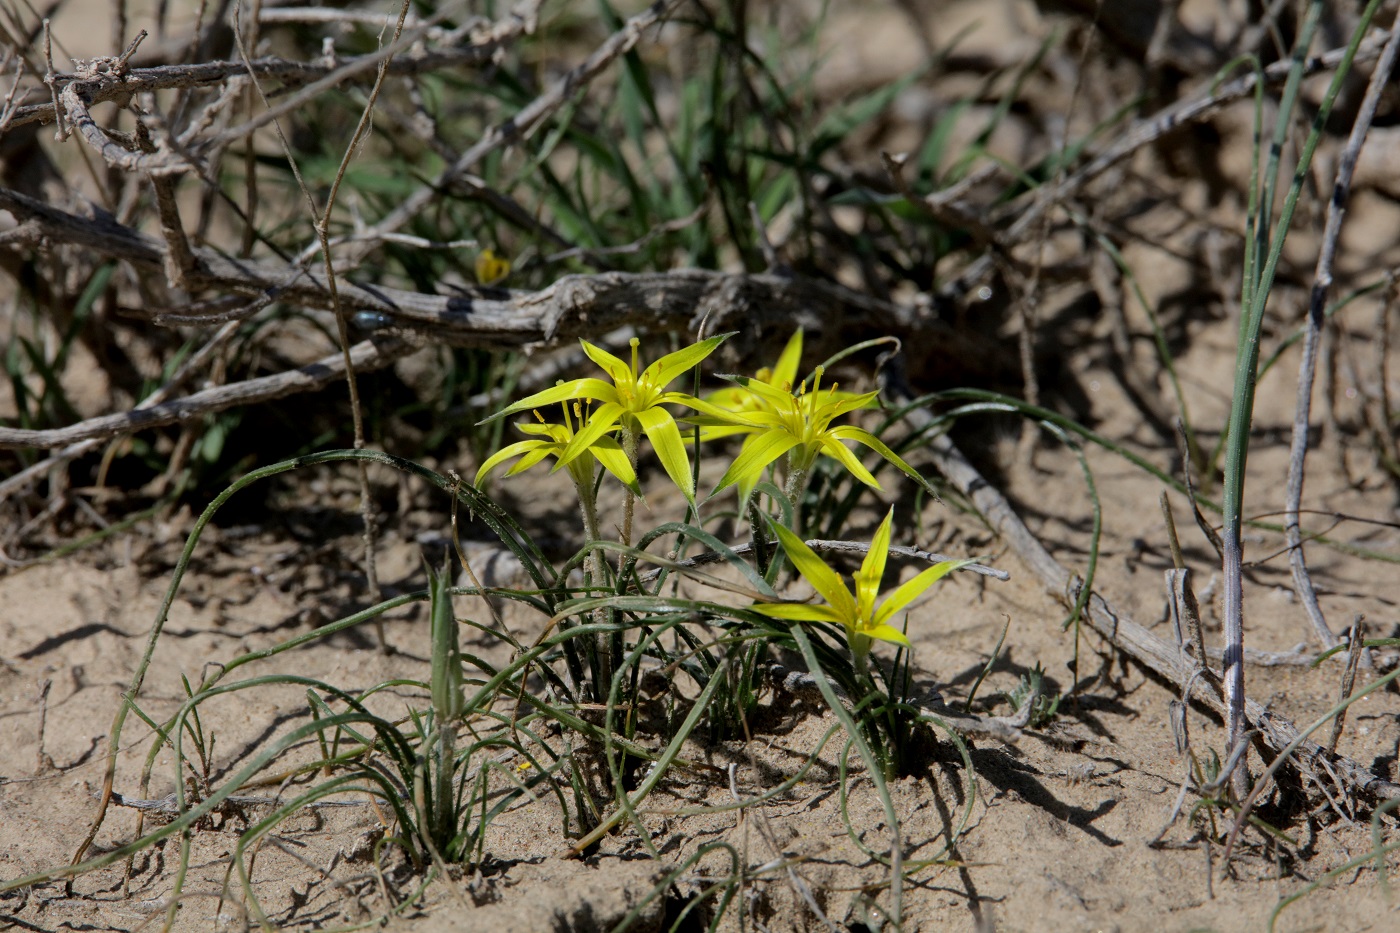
[0,188,952,352]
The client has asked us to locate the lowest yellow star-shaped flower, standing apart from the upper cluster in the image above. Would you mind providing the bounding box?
[753,509,972,657]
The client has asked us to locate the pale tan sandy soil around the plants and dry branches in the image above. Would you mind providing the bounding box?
[8,4,1400,933]
